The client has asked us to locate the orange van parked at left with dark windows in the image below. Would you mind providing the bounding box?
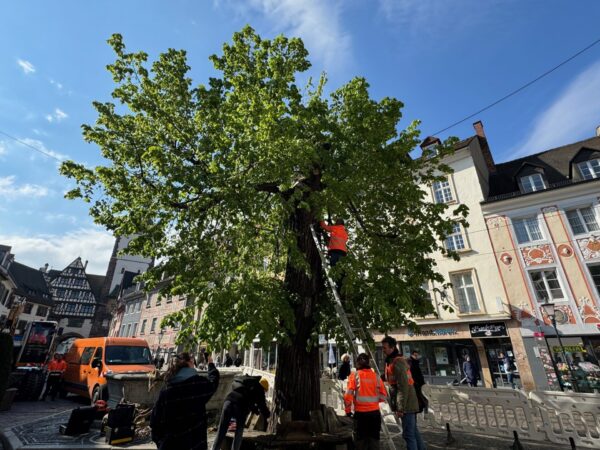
[63,337,154,404]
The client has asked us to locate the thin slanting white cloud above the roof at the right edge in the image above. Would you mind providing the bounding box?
[507,61,600,159]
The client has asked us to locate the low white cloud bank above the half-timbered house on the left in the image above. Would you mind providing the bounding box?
[0,228,115,275]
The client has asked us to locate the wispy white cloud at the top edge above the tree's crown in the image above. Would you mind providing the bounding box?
[216,0,352,72]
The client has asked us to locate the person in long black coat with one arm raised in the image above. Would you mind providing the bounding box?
[150,353,219,450]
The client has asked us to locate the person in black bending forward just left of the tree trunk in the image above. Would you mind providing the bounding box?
[212,376,271,450]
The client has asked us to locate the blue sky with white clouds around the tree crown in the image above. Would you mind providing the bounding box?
[0,0,600,273]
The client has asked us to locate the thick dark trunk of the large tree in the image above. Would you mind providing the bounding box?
[275,205,323,420]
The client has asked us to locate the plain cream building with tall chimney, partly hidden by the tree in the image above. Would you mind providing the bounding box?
[375,122,532,388]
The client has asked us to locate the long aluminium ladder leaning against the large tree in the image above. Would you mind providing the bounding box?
[310,225,402,450]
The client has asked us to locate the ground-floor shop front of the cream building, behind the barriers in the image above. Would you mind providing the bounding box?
[374,322,518,387]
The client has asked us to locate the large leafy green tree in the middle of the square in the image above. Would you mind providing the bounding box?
[61,27,466,417]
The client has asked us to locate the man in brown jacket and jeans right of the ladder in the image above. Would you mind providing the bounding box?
[381,336,427,450]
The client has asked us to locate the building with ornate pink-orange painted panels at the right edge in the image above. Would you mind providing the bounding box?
[482,129,600,392]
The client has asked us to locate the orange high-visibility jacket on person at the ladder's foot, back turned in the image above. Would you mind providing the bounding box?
[344,369,387,413]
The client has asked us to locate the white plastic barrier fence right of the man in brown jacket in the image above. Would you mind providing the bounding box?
[423,385,600,448]
